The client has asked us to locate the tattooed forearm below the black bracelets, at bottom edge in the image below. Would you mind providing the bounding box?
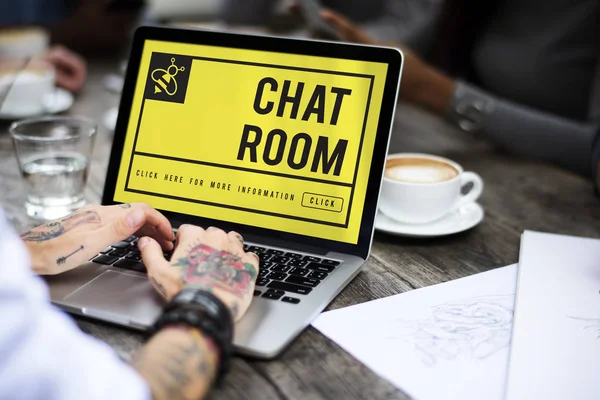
[132,326,219,400]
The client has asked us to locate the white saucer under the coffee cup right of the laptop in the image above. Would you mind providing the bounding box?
[375,203,484,238]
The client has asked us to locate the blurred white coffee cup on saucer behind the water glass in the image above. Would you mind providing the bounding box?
[0,61,56,116]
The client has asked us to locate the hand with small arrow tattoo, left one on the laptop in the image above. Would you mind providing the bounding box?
[21,203,175,275]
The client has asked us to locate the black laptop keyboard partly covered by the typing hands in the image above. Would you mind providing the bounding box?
[92,236,341,304]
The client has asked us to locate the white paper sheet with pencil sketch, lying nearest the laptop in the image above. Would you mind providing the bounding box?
[313,265,517,400]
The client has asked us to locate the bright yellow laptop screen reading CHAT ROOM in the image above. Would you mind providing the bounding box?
[113,40,388,244]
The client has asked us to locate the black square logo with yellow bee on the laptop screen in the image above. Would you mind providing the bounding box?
[144,53,192,103]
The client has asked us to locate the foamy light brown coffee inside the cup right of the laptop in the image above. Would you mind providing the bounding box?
[385,157,459,183]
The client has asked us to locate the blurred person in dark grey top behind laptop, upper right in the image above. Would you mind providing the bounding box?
[296,0,600,176]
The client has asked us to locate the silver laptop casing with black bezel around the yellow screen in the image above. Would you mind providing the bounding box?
[46,27,402,358]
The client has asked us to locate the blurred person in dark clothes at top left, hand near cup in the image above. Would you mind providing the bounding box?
[0,0,144,92]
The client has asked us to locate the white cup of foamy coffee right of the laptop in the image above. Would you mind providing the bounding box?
[379,153,483,224]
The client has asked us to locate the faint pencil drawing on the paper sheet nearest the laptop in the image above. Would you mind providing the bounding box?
[388,294,515,366]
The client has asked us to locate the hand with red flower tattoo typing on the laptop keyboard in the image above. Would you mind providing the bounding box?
[139,225,258,320]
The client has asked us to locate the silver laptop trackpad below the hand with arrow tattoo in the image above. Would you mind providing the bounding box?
[63,271,164,327]
